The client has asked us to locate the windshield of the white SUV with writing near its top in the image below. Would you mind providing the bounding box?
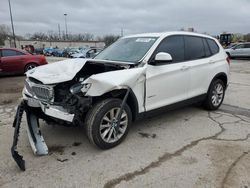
[95,37,157,63]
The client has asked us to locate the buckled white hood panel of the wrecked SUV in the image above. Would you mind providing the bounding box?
[26,59,89,84]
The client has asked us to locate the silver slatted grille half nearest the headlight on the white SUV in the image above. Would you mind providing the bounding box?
[32,85,54,101]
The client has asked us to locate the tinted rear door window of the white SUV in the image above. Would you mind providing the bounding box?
[184,36,206,61]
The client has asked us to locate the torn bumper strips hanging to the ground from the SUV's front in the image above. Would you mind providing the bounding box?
[11,101,48,171]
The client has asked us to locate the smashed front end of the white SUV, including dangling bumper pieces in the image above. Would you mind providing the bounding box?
[11,60,145,170]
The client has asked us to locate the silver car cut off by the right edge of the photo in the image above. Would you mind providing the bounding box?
[225,42,250,58]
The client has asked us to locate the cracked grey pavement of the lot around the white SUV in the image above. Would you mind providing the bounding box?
[0,57,250,188]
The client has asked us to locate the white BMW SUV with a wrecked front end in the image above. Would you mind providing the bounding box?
[20,32,229,154]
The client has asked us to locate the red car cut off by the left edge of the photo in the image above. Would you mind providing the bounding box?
[0,48,47,75]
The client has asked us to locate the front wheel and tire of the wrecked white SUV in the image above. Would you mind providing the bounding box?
[85,98,132,149]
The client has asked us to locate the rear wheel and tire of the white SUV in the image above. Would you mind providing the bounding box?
[204,79,226,110]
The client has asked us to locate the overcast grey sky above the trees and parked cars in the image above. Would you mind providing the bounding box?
[0,0,250,35]
